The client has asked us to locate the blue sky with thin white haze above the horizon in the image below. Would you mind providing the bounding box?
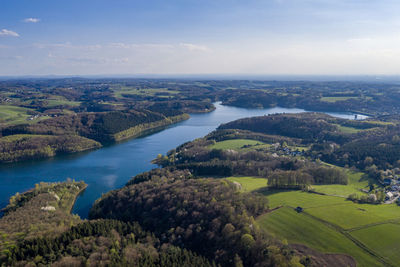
[0,0,400,76]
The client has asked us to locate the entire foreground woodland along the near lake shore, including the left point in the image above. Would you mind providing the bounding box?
[0,177,312,267]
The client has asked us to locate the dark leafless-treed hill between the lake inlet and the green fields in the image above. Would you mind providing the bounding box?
[90,176,301,266]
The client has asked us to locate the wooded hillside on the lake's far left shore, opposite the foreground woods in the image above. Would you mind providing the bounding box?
[0,109,189,163]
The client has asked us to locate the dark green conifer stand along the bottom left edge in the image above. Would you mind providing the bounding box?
[0,220,215,267]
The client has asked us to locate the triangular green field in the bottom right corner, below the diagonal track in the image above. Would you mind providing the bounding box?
[351,224,400,265]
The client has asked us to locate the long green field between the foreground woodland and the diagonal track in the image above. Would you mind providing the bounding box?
[257,207,382,266]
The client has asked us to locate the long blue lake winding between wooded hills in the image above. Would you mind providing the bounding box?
[0,103,365,218]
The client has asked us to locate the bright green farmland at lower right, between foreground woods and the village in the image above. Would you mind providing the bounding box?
[233,176,400,266]
